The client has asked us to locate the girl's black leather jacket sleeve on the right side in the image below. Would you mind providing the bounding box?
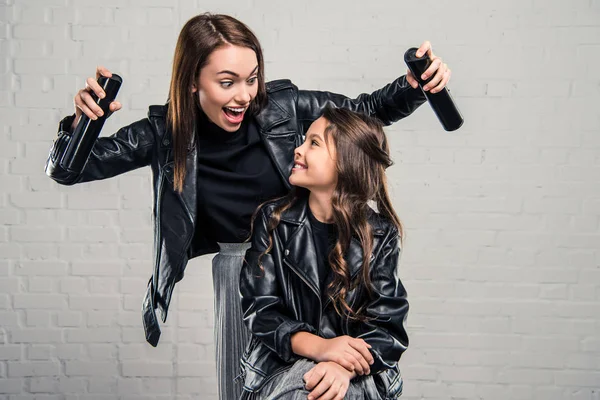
[352,230,408,374]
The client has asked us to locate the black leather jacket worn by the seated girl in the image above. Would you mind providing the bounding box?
[240,197,408,399]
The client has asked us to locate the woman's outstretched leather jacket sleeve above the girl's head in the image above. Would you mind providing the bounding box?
[297,75,426,131]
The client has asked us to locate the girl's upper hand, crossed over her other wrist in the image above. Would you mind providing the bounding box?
[315,336,374,375]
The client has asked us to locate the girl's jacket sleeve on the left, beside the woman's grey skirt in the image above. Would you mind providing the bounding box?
[240,206,316,362]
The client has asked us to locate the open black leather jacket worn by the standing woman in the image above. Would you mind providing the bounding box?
[46,76,425,346]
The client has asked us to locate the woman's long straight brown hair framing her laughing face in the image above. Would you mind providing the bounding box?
[167,13,267,192]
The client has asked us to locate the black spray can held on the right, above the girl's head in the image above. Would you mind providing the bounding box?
[404,47,464,131]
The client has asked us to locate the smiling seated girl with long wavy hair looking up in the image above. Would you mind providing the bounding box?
[240,108,408,400]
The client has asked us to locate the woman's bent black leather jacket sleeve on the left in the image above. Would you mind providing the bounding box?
[45,115,155,185]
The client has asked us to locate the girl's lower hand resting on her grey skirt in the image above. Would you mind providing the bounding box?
[303,361,356,400]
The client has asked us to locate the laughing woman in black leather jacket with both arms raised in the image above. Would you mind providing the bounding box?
[46,14,450,399]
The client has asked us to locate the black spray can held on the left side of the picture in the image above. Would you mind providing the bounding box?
[60,74,123,174]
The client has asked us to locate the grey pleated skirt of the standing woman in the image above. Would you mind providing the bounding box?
[212,243,250,400]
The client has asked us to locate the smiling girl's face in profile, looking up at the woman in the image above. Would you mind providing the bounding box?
[289,117,337,193]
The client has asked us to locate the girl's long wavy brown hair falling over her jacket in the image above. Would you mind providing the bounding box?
[254,108,404,320]
